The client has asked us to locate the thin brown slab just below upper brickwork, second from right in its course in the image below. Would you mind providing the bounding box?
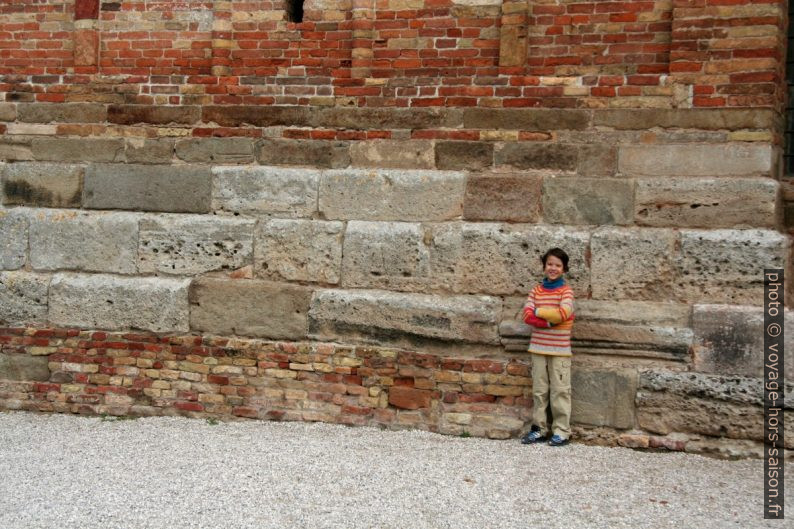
[463,108,590,131]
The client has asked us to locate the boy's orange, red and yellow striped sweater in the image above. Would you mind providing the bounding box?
[524,284,574,356]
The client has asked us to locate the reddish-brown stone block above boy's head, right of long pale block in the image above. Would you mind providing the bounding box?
[463,173,543,222]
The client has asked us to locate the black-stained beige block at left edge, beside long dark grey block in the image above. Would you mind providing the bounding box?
[2,162,85,208]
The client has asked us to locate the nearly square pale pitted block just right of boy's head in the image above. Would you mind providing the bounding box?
[590,228,676,301]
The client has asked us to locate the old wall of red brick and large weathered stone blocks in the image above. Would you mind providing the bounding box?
[0,0,794,455]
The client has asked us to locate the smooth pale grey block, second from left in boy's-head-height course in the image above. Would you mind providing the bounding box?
[30,210,140,274]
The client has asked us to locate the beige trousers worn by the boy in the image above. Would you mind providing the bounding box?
[532,353,571,439]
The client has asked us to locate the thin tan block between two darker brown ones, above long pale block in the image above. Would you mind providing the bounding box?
[350,140,435,169]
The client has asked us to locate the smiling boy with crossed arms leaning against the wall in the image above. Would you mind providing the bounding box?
[521,248,574,446]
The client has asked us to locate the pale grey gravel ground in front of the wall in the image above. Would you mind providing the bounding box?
[0,413,794,529]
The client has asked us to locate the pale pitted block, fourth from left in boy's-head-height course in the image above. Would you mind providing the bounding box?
[254,219,344,284]
